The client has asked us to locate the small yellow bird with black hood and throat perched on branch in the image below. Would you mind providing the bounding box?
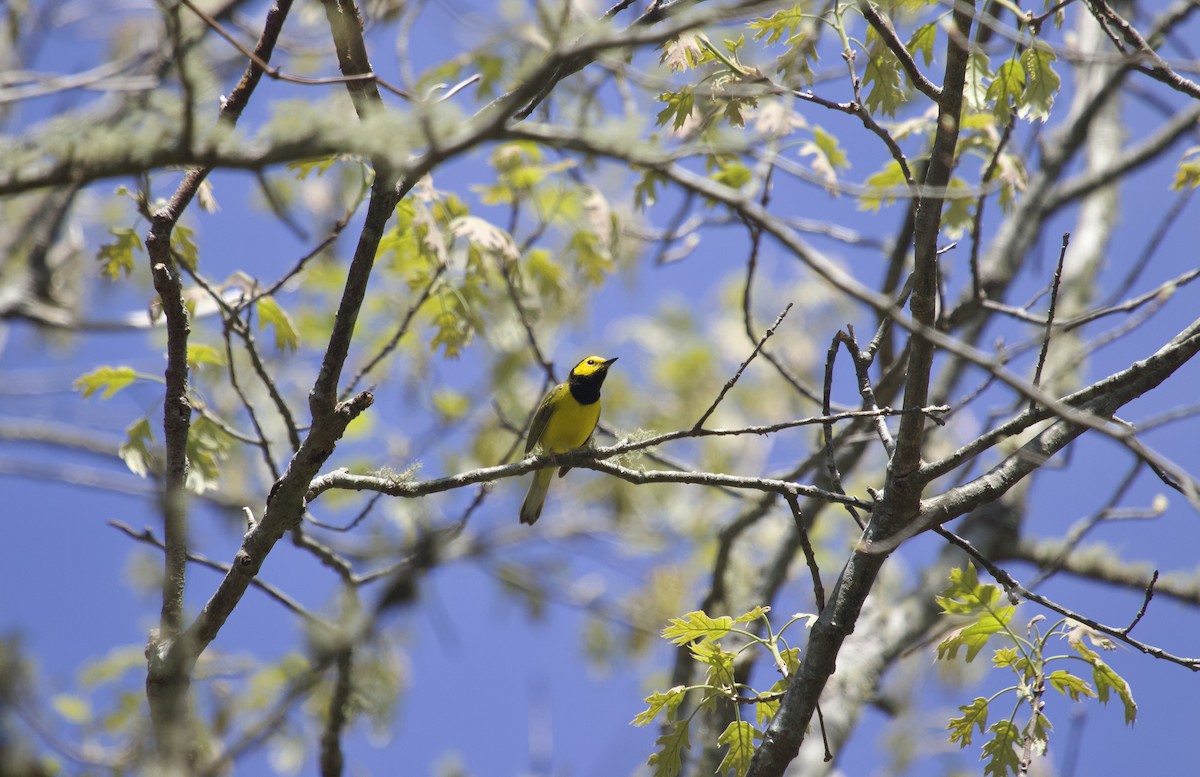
[521,356,617,526]
